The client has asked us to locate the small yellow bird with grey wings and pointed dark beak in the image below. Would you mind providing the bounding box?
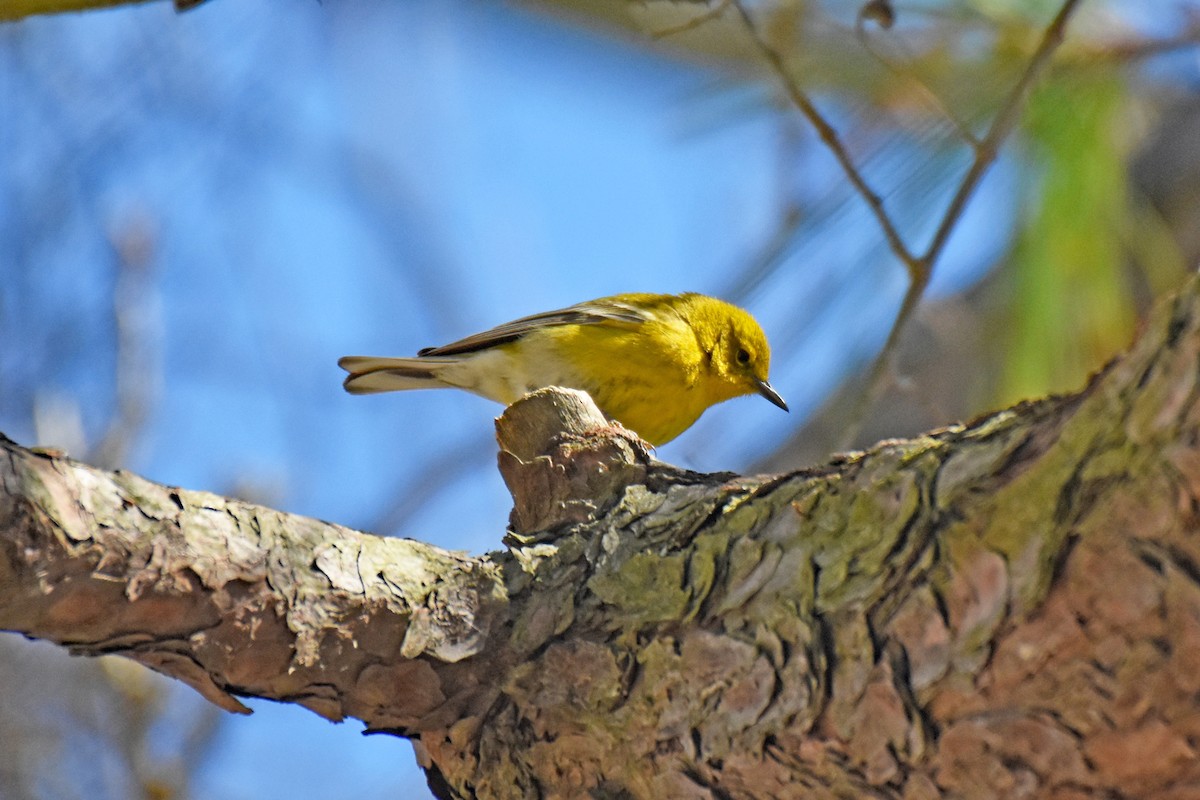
[337,293,787,446]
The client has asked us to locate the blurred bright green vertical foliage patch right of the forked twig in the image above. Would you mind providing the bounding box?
[997,68,1180,404]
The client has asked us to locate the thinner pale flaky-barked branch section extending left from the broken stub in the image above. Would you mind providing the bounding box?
[0,440,504,728]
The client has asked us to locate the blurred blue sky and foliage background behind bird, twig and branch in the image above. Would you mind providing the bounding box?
[0,0,1200,800]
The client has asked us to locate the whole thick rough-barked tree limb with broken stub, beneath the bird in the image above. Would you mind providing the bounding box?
[0,281,1200,799]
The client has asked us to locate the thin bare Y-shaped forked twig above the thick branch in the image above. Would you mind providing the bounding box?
[732,0,1080,447]
